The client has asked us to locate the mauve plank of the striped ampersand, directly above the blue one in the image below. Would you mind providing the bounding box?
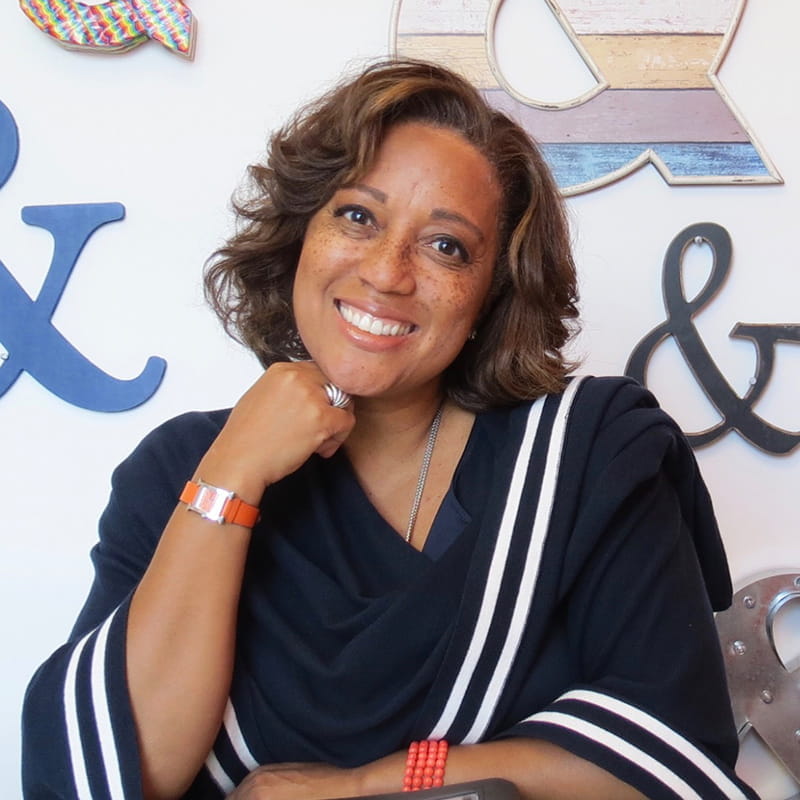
[484,89,750,143]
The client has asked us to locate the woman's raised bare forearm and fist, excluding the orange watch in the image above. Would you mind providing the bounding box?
[127,362,355,800]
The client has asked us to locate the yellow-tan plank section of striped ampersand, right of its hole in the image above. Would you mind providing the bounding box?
[579,34,724,89]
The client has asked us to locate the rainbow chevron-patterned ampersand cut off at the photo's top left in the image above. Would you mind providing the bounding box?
[19,0,195,58]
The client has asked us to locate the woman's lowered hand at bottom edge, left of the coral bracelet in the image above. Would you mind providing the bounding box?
[227,764,361,800]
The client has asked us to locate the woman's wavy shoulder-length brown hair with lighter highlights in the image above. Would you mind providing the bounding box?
[205,59,578,411]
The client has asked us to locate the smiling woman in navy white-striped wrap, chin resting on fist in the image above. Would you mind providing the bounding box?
[23,62,754,800]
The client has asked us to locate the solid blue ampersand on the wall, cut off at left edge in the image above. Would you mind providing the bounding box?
[0,102,166,411]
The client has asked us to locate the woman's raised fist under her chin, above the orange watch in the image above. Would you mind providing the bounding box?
[197,361,355,503]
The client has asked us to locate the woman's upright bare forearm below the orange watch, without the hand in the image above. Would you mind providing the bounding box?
[126,500,250,800]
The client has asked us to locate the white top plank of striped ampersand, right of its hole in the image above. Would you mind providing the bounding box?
[547,0,745,34]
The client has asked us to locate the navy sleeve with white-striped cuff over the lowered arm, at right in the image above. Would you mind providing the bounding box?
[510,381,756,800]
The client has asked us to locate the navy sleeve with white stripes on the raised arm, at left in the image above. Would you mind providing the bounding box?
[22,412,225,800]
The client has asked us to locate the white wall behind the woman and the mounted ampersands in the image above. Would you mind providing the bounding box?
[0,0,800,800]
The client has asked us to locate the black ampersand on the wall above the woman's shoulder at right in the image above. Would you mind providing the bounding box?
[625,222,800,455]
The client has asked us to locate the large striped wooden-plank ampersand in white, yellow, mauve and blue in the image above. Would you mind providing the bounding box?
[391,0,782,195]
